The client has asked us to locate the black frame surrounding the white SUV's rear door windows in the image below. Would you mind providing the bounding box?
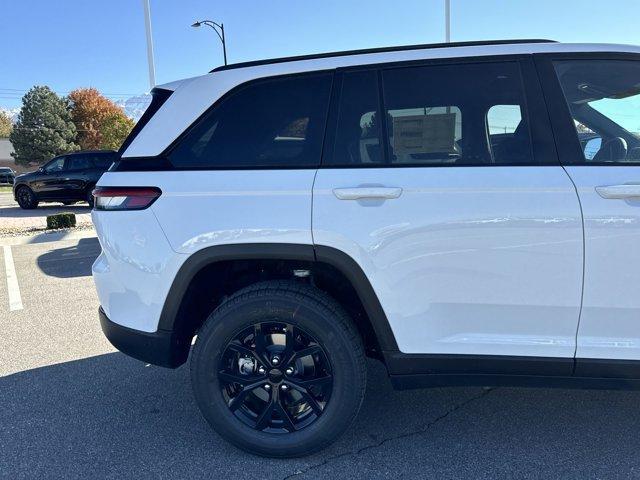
[320,54,560,169]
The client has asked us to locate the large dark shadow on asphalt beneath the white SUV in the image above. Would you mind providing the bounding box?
[0,353,640,479]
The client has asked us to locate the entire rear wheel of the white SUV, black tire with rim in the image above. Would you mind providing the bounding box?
[191,281,366,458]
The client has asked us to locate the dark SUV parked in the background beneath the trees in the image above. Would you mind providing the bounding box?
[13,150,118,209]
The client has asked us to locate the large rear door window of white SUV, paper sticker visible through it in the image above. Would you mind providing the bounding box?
[383,62,533,166]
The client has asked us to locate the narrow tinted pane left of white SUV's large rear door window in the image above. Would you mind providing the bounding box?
[326,71,384,165]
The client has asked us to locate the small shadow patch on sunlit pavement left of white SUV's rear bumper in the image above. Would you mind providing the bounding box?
[36,237,100,278]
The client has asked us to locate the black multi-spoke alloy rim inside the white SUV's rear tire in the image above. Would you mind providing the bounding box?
[218,322,333,433]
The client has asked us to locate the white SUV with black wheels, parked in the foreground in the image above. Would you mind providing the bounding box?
[93,40,640,457]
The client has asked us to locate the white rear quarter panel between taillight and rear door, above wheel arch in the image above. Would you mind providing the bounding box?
[98,169,316,254]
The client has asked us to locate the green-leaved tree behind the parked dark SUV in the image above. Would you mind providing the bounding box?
[9,86,78,165]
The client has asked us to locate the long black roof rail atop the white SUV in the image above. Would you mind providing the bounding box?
[209,38,556,73]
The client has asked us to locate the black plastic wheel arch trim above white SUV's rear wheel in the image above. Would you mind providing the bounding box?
[158,243,398,363]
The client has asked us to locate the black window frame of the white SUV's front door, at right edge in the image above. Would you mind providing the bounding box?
[533,52,640,167]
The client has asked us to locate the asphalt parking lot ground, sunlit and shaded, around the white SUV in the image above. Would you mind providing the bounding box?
[0,232,640,479]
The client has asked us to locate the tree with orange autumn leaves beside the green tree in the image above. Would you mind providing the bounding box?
[69,88,134,150]
